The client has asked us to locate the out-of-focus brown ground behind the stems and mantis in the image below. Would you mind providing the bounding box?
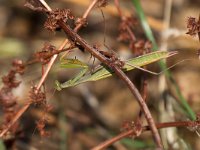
[0,0,200,150]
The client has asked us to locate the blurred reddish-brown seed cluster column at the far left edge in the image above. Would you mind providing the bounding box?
[0,59,25,136]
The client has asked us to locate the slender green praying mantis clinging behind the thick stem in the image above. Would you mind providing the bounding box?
[56,51,176,91]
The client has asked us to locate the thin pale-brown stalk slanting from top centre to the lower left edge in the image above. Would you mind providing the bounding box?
[0,0,98,137]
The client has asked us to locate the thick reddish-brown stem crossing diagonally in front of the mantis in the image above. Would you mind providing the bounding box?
[58,20,162,149]
